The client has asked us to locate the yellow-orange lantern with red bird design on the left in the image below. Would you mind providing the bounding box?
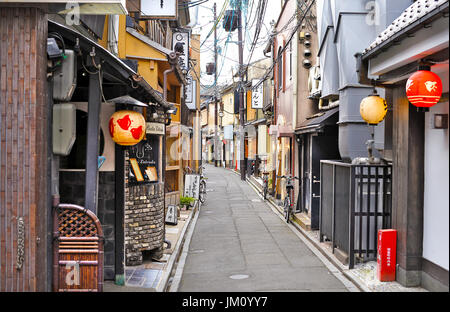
[109,110,145,146]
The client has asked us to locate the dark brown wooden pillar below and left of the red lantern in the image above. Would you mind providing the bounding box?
[392,84,425,286]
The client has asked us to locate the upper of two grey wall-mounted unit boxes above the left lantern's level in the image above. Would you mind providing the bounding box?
[53,50,77,102]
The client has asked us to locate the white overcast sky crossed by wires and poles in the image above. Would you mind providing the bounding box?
[190,0,281,85]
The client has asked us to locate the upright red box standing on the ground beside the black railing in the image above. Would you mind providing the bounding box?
[377,230,397,282]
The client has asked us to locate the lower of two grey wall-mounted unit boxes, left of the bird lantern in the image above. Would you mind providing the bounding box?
[53,103,77,156]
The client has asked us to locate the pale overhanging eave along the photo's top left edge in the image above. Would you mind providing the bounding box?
[0,0,128,15]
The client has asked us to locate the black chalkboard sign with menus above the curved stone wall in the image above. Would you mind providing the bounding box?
[128,135,160,184]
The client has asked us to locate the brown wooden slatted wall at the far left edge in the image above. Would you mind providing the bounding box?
[0,7,50,292]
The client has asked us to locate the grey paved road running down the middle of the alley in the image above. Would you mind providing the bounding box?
[178,165,347,292]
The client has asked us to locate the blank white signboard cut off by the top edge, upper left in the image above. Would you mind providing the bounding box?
[141,0,178,20]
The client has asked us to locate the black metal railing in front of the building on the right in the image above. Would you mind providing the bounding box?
[319,160,392,269]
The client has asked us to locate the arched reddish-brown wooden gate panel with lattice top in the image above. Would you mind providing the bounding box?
[53,204,103,292]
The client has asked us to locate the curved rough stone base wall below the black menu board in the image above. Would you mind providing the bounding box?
[125,183,164,266]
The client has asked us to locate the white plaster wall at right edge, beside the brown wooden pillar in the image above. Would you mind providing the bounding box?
[423,98,449,270]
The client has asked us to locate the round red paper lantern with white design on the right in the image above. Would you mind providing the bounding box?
[406,70,442,108]
